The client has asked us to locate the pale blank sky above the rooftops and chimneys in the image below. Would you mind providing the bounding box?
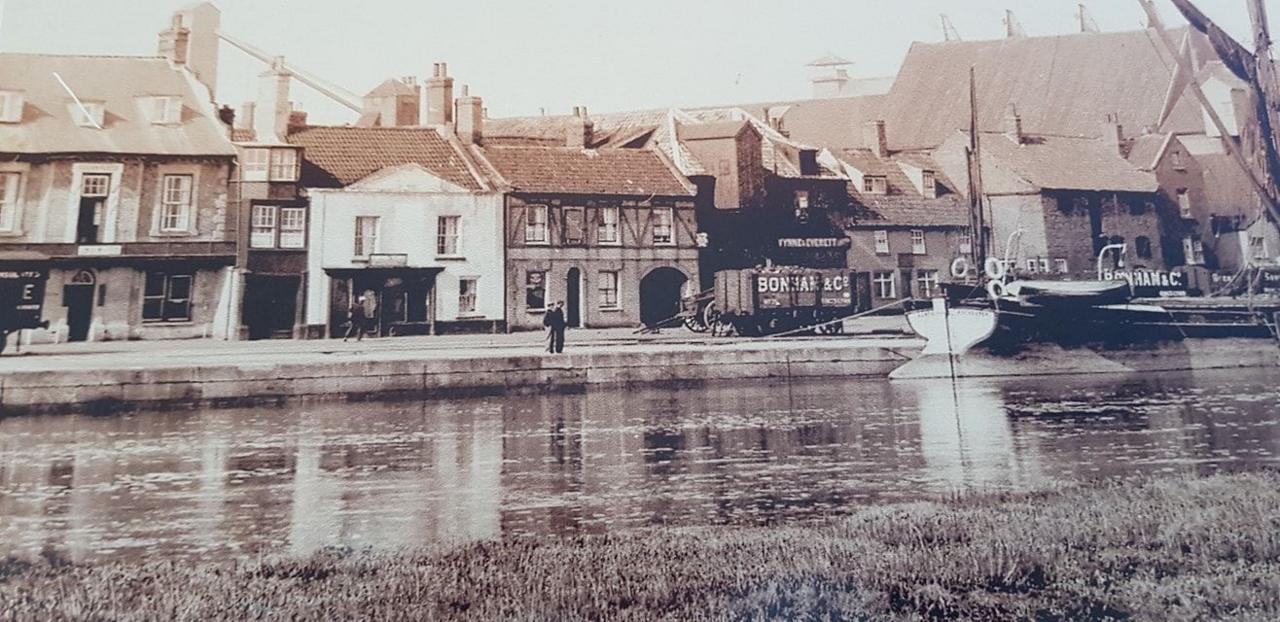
[0,0,1280,124]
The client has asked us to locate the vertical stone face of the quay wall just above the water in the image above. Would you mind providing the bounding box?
[0,340,919,415]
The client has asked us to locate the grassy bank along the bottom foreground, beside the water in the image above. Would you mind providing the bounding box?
[0,474,1280,621]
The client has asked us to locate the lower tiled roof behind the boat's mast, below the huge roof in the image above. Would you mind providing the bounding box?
[982,133,1157,195]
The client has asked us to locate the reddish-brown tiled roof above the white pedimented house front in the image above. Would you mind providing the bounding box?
[289,127,481,191]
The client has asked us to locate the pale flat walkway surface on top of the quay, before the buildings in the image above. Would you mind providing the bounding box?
[0,316,910,374]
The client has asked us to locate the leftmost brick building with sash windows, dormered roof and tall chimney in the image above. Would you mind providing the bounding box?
[0,12,238,342]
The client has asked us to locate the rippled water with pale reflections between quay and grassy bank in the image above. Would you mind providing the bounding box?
[0,370,1280,561]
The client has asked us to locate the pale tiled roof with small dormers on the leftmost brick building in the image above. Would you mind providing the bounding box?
[0,52,236,156]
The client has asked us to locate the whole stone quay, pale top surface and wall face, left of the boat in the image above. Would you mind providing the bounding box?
[0,317,923,415]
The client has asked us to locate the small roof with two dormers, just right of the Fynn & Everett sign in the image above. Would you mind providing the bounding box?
[837,150,969,227]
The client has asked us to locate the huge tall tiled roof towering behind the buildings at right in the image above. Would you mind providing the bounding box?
[884,31,1203,148]
